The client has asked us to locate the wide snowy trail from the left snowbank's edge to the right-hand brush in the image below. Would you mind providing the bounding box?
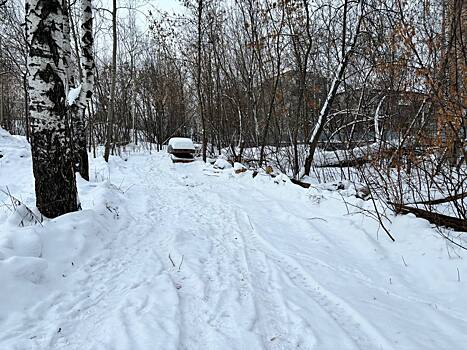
[0,144,467,350]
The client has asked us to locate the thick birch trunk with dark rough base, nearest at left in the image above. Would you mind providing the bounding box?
[26,0,78,218]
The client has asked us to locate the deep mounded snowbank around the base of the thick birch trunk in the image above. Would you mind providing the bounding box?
[0,129,124,329]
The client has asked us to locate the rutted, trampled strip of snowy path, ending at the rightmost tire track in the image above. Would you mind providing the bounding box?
[0,158,391,350]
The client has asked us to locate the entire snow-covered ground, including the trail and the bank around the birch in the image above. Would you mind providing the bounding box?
[0,130,467,350]
